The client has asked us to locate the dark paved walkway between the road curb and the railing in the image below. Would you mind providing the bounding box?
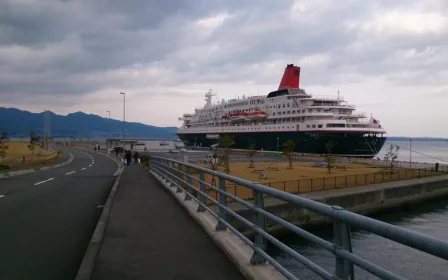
[92,165,244,280]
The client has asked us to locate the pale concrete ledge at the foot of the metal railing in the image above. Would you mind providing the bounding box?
[149,171,286,280]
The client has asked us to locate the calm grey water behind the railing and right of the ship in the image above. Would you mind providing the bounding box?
[269,141,448,280]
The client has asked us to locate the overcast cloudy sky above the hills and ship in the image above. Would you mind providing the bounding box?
[0,0,448,137]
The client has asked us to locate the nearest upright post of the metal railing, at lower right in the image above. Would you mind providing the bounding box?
[332,206,355,280]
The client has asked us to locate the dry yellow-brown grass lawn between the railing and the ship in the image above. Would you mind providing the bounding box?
[172,162,442,201]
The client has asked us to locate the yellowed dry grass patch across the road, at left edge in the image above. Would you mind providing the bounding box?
[2,141,59,168]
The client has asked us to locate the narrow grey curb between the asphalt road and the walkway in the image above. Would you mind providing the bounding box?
[75,149,124,280]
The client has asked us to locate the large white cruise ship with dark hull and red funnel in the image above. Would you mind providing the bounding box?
[177,64,386,158]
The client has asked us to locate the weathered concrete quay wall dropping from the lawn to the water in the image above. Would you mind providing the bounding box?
[222,175,448,232]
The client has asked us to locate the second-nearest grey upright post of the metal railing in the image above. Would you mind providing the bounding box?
[250,186,266,265]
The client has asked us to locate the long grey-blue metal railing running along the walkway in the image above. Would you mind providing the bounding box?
[149,157,448,280]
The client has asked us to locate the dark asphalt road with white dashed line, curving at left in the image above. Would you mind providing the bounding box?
[0,147,117,280]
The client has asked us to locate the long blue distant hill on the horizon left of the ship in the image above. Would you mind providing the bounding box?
[0,107,177,139]
